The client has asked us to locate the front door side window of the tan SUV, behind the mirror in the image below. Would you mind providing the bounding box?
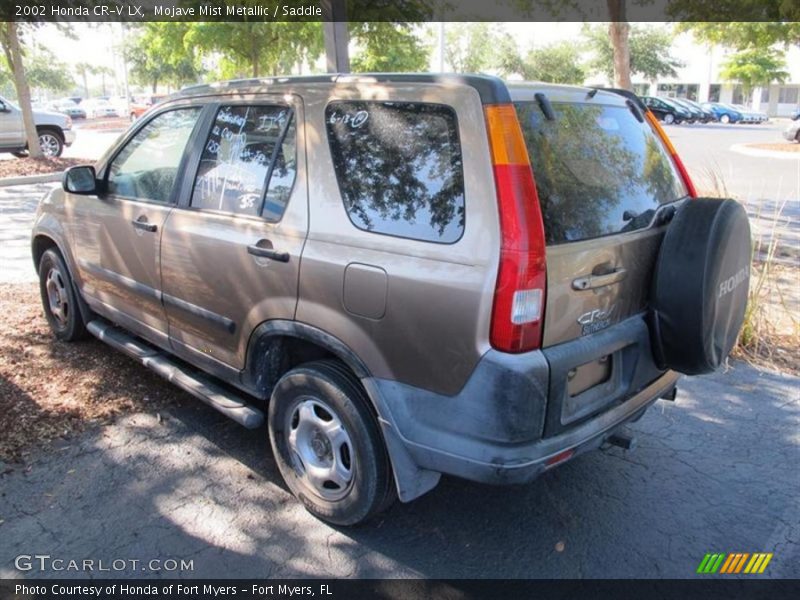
[108,106,200,204]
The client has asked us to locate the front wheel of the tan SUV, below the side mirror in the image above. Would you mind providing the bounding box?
[39,248,88,342]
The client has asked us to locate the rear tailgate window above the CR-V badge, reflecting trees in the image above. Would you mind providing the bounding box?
[516,102,687,244]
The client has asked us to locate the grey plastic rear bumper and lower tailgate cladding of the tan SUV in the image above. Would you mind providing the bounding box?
[365,316,679,501]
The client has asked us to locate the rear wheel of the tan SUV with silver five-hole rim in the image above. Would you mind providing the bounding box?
[268,361,396,525]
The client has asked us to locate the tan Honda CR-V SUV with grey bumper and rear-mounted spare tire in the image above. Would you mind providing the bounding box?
[33,75,750,524]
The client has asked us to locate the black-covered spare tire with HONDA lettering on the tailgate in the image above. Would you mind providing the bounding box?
[651,198,752,375]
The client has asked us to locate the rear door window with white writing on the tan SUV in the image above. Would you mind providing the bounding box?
[192,105,297,221]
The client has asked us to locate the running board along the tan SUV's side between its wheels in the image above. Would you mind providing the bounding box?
[86,319,264,429]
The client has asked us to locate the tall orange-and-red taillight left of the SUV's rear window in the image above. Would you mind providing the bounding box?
[485,104,547,352]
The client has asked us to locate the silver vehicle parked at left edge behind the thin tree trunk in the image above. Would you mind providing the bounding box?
[0,96,75,157]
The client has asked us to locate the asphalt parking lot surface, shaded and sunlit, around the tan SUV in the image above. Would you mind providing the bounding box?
[0,120,800,578]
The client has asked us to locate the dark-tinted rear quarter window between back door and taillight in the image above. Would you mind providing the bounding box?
[325,102,464,243]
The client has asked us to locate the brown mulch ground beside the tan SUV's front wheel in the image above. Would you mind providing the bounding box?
[0,283,185,464]
